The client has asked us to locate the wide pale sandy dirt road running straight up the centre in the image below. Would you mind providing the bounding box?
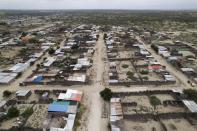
[87,34,106,131]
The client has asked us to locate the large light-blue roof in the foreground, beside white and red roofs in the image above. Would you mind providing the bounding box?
[48,104,68,113]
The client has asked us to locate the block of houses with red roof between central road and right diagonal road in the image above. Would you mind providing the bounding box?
[105,27,176,84]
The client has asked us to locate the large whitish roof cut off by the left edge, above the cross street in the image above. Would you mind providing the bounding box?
[0,72,17,84]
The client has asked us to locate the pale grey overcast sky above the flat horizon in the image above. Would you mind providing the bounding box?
[0,0,197,10]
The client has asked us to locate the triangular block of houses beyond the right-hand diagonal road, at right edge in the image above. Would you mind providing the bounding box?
[152,41,197,83]
